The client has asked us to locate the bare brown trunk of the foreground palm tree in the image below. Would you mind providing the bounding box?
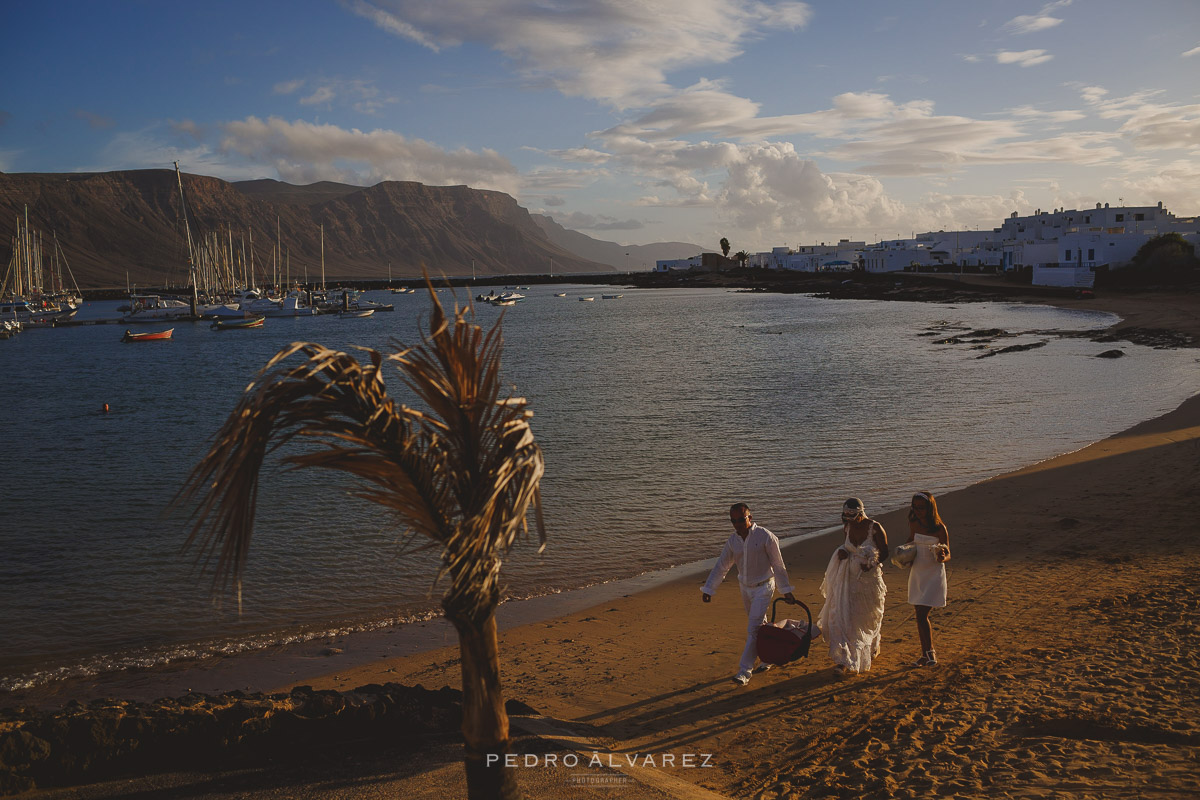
[446,609,521,800]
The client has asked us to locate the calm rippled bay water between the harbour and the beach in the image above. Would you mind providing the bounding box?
[0,285,1195,688]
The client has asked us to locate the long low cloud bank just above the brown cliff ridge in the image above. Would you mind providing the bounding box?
[221,116,521,194]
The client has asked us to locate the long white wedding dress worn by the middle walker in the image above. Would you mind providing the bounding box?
[817,534,888,672]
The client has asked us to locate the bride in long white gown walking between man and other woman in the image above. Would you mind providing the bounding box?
[817,498,888,673]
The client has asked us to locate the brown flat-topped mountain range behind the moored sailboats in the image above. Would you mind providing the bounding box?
[0,169,701,288]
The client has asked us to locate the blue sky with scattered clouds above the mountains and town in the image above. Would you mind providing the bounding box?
[0,0,1200,252]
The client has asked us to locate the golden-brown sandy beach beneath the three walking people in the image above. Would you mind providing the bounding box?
[9,294,1200,800]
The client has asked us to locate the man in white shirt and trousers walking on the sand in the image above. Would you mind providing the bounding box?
[701,503,796,686]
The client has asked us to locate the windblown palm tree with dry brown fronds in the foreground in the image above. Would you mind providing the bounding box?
[175,283,546,799]
